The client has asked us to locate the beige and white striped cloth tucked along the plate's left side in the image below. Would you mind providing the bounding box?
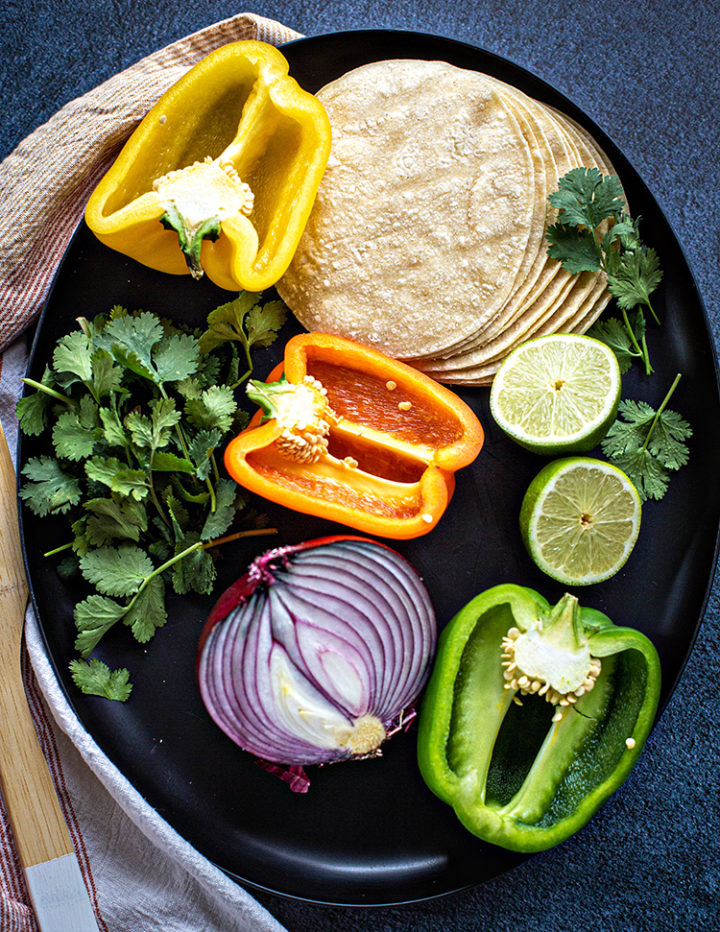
[0,13,299,932]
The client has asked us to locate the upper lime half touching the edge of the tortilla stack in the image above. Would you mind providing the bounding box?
[490,333,621,456]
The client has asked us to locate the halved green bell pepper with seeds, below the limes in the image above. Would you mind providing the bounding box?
[418,584,660,852]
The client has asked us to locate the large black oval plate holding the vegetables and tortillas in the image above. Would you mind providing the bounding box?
[20,31,720,905]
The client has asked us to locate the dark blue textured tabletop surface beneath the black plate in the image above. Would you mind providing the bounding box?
[0,0,720,932]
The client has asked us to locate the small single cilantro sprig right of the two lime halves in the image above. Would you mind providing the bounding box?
[602,374,692,500]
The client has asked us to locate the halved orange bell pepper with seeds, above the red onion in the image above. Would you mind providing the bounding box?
[225,333,483,539]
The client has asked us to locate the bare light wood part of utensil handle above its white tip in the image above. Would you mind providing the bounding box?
[0,425,73,868]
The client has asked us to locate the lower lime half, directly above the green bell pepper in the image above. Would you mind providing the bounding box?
[520,456,642,586]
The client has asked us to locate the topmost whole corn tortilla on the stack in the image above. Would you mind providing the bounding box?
[278,60,543,358]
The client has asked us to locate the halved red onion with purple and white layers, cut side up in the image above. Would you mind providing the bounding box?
[198,537,437,765]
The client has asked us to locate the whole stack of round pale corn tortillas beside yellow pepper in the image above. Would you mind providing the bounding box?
[278,60,614,385]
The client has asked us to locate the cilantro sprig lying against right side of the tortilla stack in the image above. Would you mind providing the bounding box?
[546,168,662,375]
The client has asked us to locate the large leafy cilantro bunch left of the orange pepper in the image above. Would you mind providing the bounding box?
[17,293,286,700]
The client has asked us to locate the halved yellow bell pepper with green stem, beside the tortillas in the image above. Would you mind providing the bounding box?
[85,40,331,292]
